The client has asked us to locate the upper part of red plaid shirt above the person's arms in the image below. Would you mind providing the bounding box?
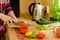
[0,0,12,13]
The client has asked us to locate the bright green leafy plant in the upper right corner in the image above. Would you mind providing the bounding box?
[51,0,60,22]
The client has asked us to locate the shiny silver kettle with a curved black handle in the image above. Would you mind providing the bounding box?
[29,3,44,20]
